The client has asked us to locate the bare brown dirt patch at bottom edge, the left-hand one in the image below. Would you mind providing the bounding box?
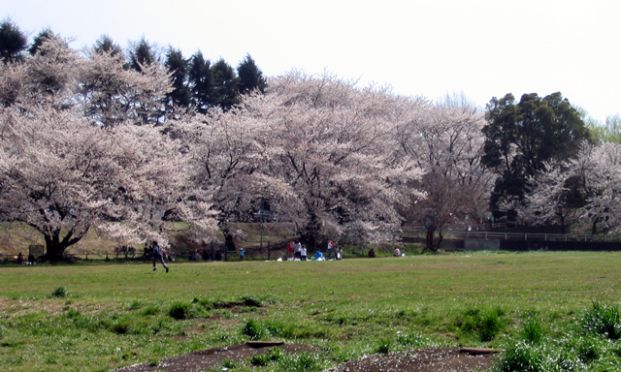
[117,342,317,372]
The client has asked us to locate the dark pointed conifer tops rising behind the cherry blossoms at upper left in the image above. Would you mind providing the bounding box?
[0,20,267,113]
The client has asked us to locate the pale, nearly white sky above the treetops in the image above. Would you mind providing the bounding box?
[0,0,621,121]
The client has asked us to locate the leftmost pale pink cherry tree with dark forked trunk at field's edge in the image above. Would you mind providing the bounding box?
[0,109,203,260]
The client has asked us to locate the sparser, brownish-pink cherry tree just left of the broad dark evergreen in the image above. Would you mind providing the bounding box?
[398,97,494,251]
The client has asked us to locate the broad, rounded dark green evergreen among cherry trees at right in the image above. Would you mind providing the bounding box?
[481,93,589,214]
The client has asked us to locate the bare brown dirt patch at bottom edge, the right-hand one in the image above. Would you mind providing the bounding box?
[330,348,498,372]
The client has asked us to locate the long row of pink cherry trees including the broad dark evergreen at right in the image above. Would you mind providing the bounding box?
[0,27,621,260]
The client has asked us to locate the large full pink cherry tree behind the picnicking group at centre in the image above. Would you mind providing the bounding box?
[243,73,420,246]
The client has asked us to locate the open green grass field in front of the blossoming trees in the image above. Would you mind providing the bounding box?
[0,252,621,371]
